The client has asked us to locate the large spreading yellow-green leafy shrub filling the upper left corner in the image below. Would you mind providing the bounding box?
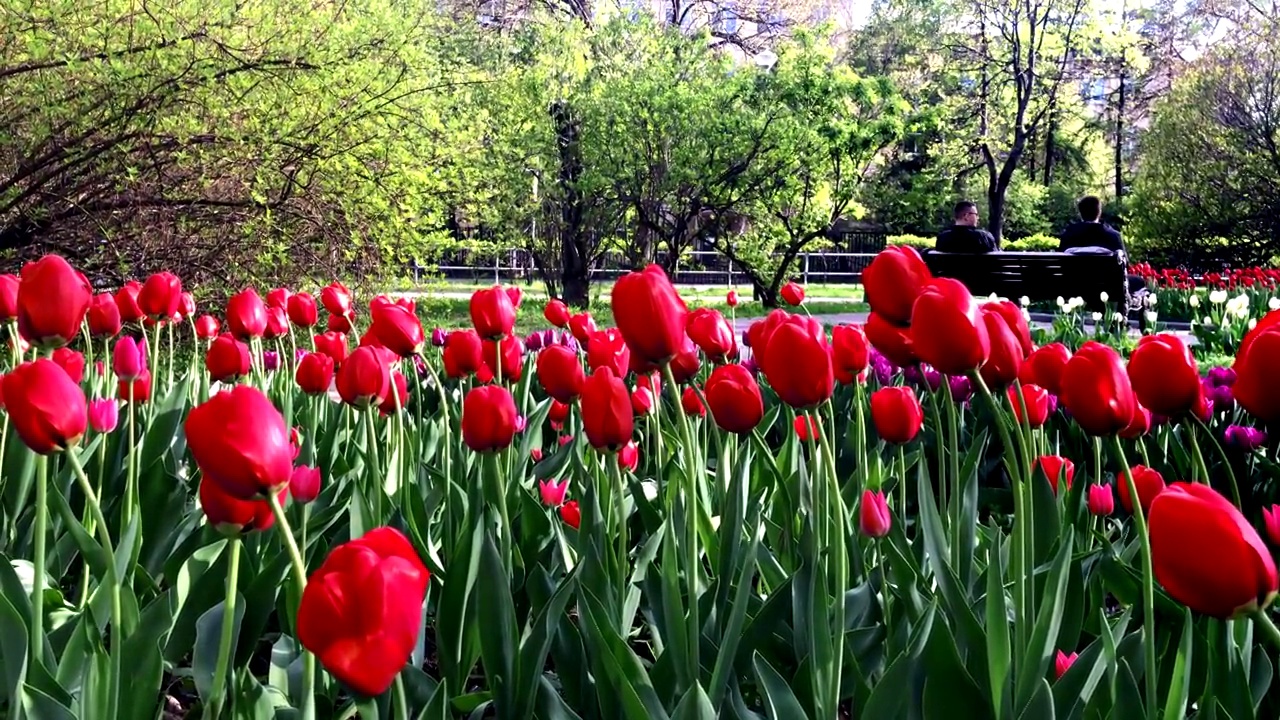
[0,0,468,284]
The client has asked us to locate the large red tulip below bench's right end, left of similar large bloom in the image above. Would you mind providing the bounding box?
[1061,340,1135,436]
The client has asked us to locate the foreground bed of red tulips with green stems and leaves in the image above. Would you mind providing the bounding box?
[0,247,1280,720]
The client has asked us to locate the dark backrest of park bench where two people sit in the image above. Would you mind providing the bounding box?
[924,250,1129,309]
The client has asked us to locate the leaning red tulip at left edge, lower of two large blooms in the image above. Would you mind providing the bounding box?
[0,357,88,455]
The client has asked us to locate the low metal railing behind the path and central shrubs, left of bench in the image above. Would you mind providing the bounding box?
[410,244,879,286]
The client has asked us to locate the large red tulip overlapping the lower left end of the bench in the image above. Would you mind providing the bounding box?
[911,275,988,375]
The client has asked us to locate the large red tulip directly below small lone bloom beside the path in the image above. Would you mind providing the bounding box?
[753,315,835,409]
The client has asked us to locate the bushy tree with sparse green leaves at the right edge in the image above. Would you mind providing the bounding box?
[1133,5,1280,266]
